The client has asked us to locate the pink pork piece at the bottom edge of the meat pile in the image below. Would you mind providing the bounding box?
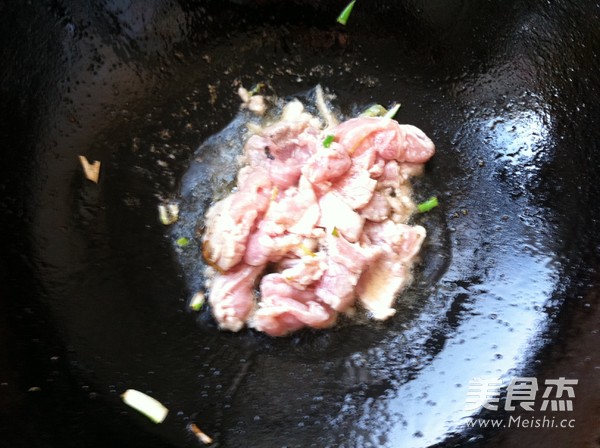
[250,274,336,336]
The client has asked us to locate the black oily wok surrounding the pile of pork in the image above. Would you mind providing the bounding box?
[0,0,600,447]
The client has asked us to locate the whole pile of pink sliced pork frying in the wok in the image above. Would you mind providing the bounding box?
[203,108,434,336]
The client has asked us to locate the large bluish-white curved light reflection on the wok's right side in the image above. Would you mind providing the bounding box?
[336,99,562,447]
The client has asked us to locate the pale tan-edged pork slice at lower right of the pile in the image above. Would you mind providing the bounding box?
[357,219,426,320]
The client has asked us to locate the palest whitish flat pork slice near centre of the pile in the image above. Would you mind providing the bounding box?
[317,191,364,242]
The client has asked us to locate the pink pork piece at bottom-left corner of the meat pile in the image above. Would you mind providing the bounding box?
[208,263,264,331]
